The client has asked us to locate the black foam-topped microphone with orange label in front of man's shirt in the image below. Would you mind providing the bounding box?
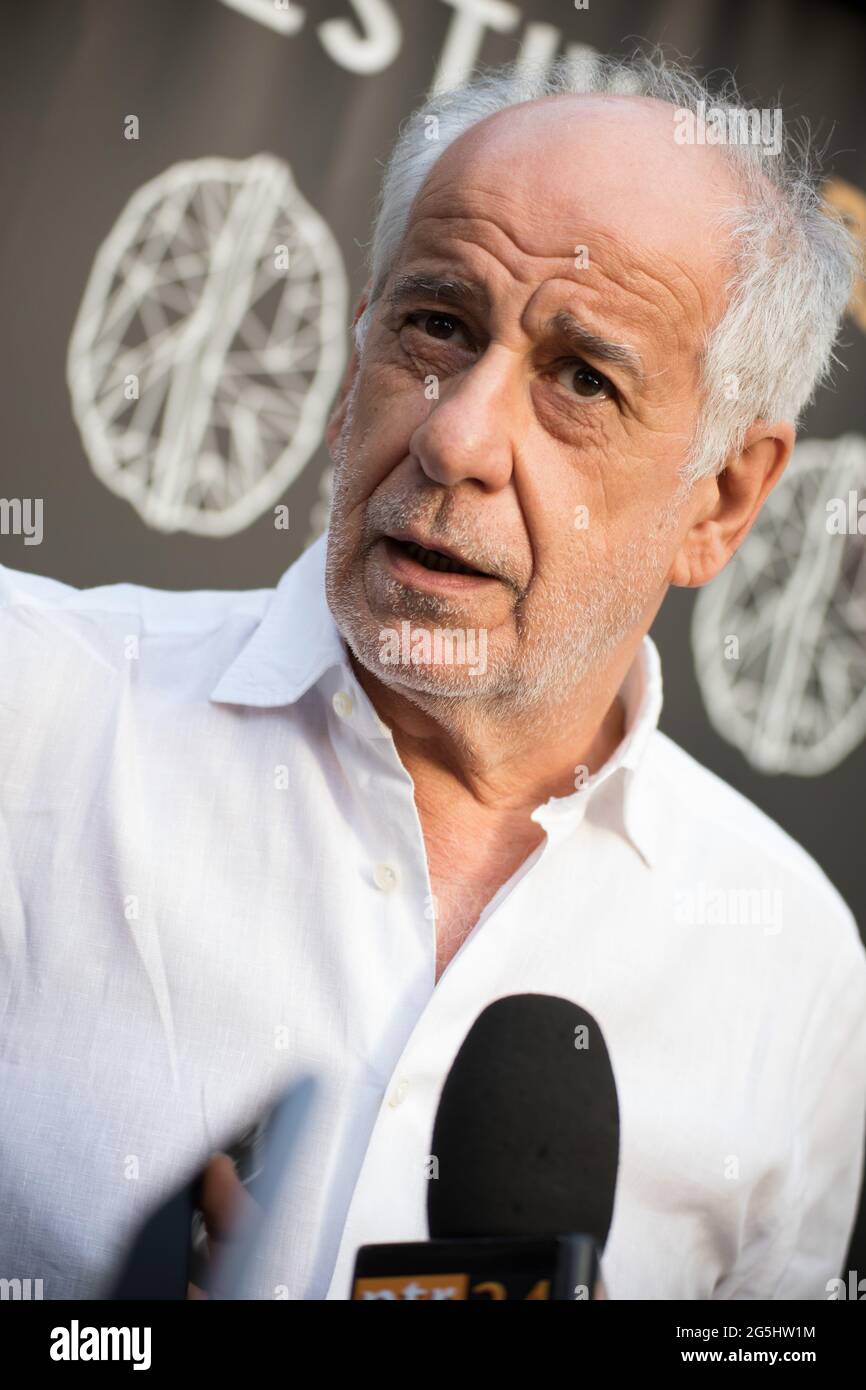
[352,994,620,1301]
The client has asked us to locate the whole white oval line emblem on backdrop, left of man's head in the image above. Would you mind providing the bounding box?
[67,154,348,537]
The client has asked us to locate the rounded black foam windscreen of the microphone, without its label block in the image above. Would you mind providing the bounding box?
[427,994,620,1247]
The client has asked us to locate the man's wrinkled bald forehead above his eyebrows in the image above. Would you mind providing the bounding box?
[399,96,737,347]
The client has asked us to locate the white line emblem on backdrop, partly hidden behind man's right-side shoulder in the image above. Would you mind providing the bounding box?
[692,434,866,777]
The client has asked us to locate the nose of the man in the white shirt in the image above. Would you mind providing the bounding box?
[409,345,521,492]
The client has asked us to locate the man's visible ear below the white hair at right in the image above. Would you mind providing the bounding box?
[669,420,794,588]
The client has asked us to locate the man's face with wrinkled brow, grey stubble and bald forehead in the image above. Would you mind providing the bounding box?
[328,97,726,706]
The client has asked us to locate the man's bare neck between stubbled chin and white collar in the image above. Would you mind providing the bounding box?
[350,634,642,812]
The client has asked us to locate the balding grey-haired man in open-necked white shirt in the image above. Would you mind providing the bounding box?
[0,60,866,1300]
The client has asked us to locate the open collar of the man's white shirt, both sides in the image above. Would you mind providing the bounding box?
[210,535,662,865]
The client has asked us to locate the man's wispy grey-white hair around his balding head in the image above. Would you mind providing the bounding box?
[354,50,858,484]
